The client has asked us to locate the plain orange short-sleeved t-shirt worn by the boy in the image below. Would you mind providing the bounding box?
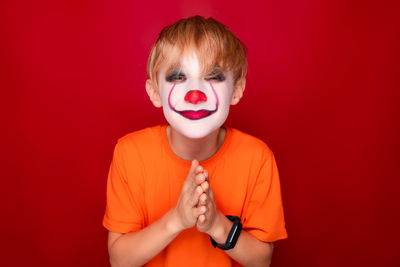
[103,125,287,267]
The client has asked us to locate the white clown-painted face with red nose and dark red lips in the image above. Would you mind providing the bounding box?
[158,54,234,138]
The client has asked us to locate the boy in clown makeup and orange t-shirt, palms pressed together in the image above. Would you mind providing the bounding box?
[103,16,287,266]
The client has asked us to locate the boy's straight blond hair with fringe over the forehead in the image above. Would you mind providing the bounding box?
[147,16,247,84]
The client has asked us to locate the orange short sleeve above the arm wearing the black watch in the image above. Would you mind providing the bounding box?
[243,150,287,242]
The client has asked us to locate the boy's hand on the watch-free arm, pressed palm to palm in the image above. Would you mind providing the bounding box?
[173,160,209,231]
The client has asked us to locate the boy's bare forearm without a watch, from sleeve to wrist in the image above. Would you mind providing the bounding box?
[109,210,180,267]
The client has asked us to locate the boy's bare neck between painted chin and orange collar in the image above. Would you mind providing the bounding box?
[167,125,226,161]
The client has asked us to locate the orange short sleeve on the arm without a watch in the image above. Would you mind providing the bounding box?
[103,142,144,233]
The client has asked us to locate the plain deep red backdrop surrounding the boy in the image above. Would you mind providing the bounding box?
[0,0,400,267]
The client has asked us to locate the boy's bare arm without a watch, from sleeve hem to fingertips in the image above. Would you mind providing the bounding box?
[108,161,208,267]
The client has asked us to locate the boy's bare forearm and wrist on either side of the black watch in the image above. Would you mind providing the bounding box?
[211,213,273,267]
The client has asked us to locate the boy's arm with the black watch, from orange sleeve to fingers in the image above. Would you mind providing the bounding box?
[197,149,287,266]
